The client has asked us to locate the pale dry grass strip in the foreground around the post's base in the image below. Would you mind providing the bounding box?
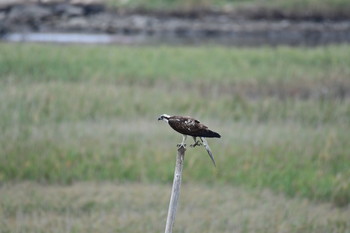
[0,183,350,233]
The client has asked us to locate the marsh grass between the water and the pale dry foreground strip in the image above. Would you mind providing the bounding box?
[0,44,350,206]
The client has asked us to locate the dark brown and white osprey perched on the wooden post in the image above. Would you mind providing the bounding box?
[158,114,221,166]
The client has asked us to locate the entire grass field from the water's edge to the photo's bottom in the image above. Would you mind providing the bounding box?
[0,43,350,232]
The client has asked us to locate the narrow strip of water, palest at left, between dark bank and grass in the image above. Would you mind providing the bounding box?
[1,26,350,46]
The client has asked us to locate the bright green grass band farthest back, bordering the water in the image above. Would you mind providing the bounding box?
[0,44,350,83]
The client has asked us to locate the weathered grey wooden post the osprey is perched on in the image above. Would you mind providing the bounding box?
[165,146,186,233]
